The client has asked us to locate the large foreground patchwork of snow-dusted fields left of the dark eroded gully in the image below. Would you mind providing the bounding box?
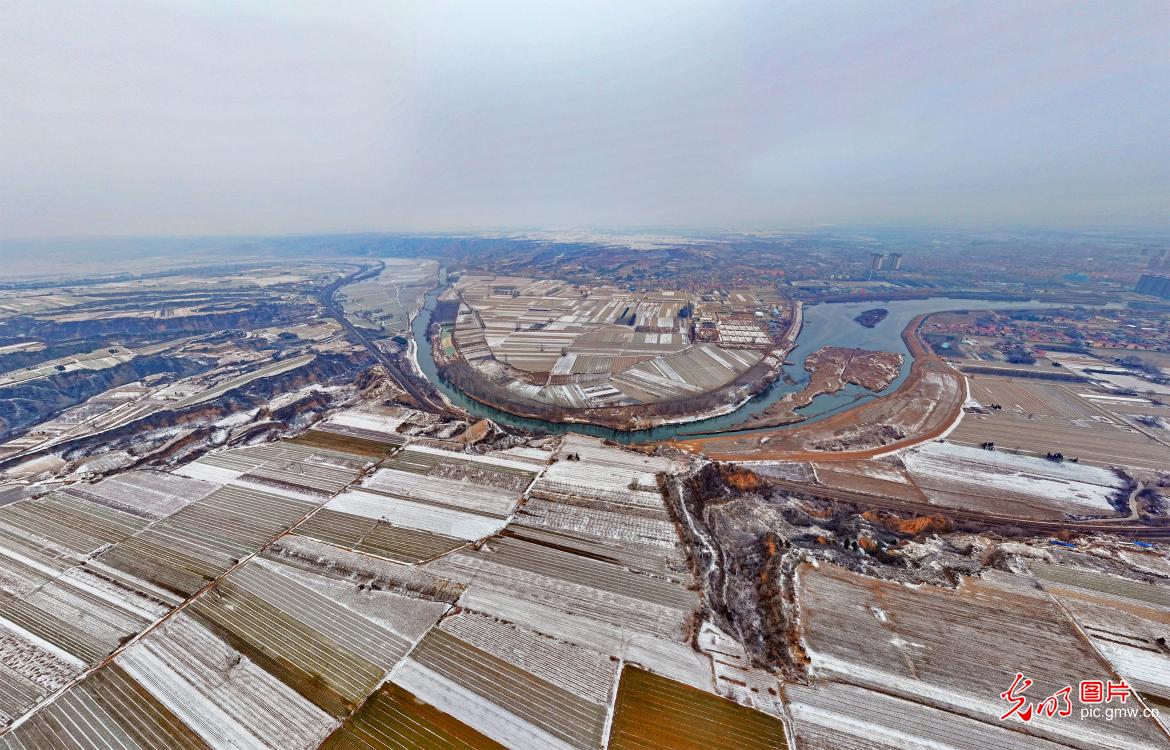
[0,417,809,750]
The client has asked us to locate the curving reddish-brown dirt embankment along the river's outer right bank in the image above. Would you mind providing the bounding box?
[670,316,966,461]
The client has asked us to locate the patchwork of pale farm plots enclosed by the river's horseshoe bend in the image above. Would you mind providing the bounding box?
[452,276,771,408]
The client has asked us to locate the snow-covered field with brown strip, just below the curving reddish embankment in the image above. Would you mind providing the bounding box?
[901,442,1129,518]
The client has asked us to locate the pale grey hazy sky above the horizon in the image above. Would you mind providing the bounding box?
[0,0,1170,238]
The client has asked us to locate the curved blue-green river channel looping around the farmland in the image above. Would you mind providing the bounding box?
[411,275,1052,443]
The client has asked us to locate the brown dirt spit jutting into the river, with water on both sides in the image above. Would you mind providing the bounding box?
[742,346,902,428]
